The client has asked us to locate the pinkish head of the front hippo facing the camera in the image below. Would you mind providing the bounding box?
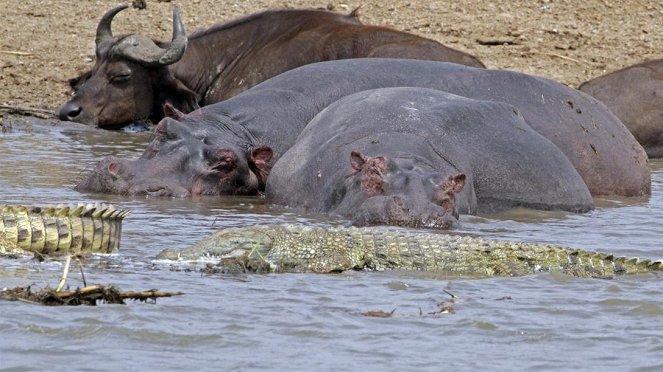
[333,151,465,229]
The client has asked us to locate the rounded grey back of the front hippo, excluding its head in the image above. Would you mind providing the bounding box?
[266,88,593,214]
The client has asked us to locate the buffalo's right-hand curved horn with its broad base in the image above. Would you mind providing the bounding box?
[114,7,188,66]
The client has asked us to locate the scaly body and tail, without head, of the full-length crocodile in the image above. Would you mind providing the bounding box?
[254,225,663,278]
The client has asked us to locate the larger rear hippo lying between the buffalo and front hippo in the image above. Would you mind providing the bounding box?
[76,58,651,197]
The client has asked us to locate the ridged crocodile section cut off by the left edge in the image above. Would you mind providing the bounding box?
[0,204,129,256]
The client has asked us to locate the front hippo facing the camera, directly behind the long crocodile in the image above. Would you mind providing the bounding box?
[265,87,593,228]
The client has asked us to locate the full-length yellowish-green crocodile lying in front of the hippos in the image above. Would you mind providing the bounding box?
[156,224,663,278]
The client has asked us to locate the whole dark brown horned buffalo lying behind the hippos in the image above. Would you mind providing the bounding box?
[60,5,483,129]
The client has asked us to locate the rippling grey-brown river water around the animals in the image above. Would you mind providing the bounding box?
[0,118,663,371]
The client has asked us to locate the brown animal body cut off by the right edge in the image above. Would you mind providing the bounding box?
[578,59,663,158]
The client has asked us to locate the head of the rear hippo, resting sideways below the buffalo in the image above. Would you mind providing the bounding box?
[75,117,272,197]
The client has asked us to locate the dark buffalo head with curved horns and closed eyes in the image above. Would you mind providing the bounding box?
[59,5,196,129]
